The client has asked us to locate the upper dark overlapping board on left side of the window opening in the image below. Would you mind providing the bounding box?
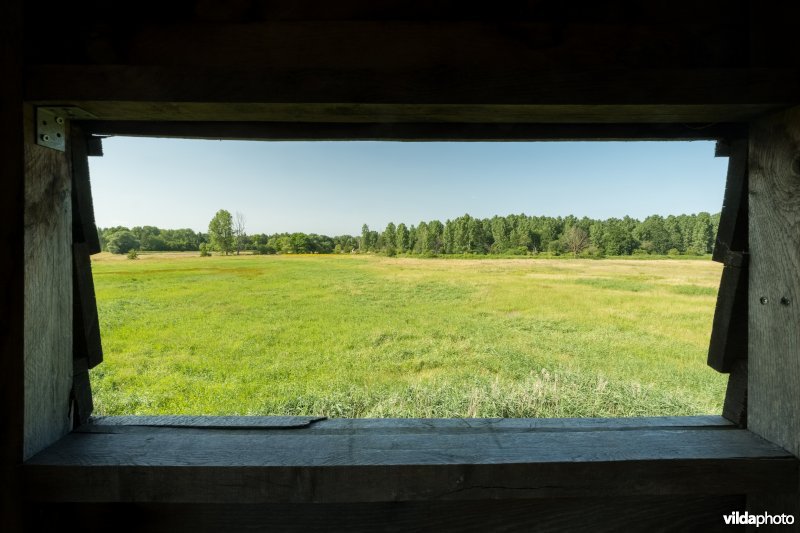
[69,125,100,254]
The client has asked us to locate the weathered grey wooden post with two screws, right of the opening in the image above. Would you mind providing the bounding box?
[748,108,800,455]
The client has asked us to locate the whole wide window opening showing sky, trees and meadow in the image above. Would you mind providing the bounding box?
[91,137,727,418]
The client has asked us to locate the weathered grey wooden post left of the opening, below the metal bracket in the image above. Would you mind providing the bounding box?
[24,106,72,458]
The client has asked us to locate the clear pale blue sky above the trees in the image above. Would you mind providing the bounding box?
[89,137,727,235]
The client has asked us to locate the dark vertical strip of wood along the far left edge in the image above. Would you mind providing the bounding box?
[0,0,25,531]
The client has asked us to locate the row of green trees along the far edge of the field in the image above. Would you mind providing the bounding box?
[98,209,719,257]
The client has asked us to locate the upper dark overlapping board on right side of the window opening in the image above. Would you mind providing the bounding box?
[712,138,748,263]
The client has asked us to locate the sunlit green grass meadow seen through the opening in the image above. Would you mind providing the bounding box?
[91,254,725,417]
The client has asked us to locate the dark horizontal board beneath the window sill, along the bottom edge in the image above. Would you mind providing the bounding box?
[25,495,745,533]
